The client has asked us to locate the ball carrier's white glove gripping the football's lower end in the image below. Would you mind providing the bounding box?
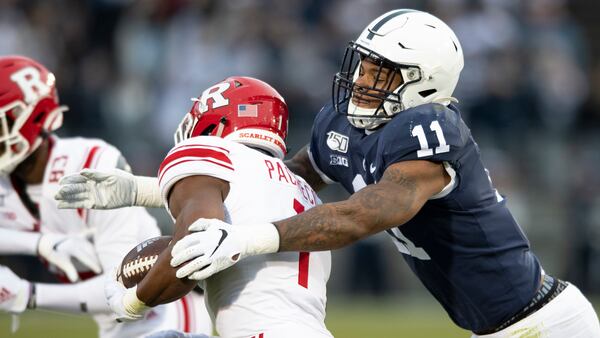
[104,278,150,323]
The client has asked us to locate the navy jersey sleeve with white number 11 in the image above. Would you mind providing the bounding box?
[380,104,470,167]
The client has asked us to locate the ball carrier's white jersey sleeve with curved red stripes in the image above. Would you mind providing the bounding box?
[158,136,235,205]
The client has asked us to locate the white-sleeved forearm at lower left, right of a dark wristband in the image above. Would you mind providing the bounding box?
[35,275,111,314]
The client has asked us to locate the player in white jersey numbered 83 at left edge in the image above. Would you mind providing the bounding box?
[0,56,211,338]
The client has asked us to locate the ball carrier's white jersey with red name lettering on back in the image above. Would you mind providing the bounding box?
[159,136,331,338]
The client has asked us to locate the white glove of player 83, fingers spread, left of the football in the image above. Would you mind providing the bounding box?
[37,230,102,282]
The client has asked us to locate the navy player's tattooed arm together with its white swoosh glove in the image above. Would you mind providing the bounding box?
[171,161,450,280]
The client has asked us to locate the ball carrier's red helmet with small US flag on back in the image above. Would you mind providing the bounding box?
[175,76,288,159]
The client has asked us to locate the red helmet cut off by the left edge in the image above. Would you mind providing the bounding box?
[0,56,67,175]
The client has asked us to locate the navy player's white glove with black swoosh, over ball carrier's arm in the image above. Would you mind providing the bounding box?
[171,218,279,280]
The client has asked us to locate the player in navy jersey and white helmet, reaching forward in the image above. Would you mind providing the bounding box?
[56,9,600,338]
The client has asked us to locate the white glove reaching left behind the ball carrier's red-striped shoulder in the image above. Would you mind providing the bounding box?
[54,169,162,209]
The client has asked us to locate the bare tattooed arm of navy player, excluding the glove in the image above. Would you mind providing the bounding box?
[274,161,450,251]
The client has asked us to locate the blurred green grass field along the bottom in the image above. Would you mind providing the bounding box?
[0,297,599,338]
